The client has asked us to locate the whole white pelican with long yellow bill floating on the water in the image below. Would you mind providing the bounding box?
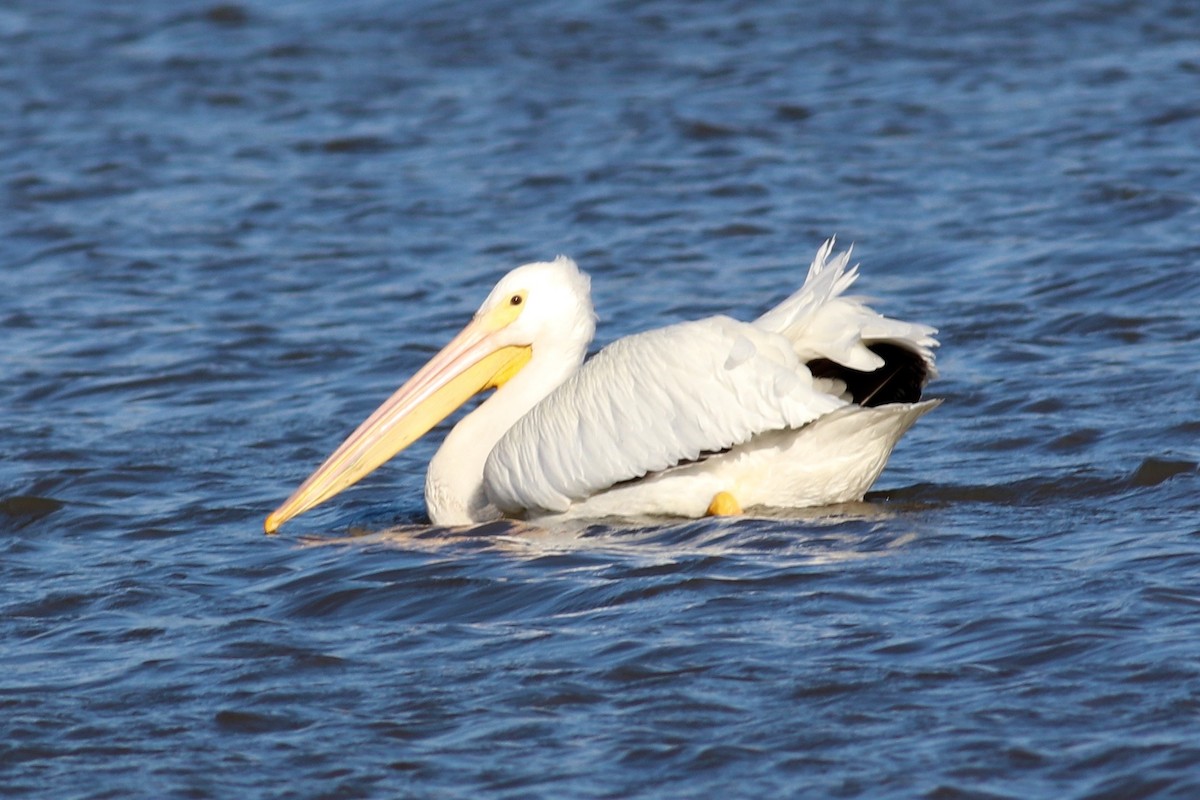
[265,240,940,533]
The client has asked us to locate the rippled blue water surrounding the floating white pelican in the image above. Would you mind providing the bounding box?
[0,0,1200,800]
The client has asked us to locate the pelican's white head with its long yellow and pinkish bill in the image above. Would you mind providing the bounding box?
[264,255,595,534]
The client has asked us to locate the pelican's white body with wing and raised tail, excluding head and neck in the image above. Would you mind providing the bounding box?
[439,241,937,522]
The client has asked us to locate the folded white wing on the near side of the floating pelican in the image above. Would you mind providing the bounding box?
[484,317,846,512]
